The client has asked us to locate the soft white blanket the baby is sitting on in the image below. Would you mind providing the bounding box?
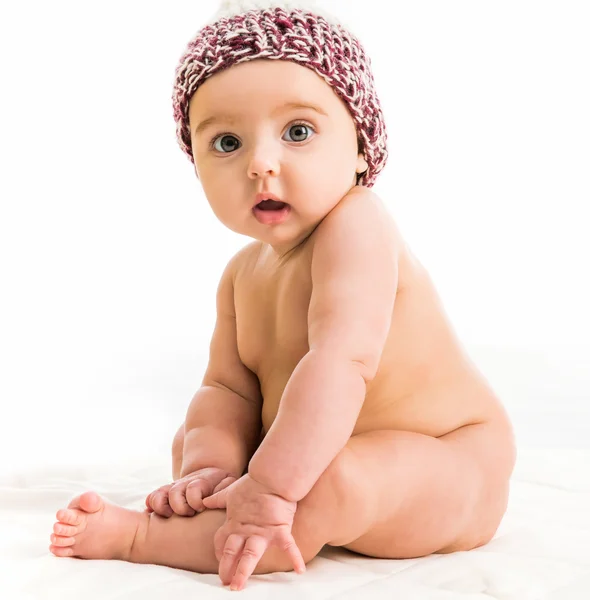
[0,447,590,600]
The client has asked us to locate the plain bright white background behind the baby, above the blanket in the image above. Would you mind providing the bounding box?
[0,0,590,469]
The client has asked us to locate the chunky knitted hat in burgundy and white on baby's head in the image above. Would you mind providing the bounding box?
[172,0,387,187]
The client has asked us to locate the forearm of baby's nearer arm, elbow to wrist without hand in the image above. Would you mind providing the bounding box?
[248,350,366,501]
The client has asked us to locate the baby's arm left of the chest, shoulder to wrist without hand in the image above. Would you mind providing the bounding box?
[180,250,262,477]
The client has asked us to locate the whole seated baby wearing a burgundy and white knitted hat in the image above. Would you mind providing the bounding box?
[50,0,515,589]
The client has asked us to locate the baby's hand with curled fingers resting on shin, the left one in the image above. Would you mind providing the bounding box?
[145,467,236,517]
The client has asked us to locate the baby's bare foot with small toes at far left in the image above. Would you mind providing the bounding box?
[49,492,149,560]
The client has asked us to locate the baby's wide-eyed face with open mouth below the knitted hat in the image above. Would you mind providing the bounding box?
[189,60,367,254]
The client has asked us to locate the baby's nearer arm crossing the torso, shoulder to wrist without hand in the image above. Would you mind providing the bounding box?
[249,187,398,501]
